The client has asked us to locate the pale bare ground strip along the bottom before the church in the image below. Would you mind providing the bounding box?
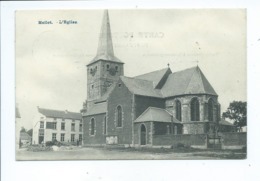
[16,147,246,160]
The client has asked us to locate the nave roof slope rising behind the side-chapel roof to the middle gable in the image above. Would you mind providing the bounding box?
[135,68,172,88]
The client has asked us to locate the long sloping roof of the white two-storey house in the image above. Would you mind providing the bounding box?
[38,107,82,120]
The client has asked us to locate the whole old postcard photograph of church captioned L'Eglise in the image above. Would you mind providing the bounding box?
[13,8,247,161]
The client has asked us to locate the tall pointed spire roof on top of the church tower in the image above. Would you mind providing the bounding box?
[88,10,123,65]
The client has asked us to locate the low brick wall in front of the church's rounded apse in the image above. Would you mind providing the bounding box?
[153,134,207,148]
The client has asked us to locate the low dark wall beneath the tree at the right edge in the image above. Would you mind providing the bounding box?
[220,132,247,149]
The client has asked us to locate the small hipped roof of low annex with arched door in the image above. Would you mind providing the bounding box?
[134,107,181,124]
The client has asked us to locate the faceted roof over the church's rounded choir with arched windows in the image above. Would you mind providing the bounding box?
[161,66,217,97]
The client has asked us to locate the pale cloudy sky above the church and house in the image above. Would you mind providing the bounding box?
[15,9,247,129]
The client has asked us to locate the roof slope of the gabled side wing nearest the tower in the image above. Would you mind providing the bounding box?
[120,76,162,98]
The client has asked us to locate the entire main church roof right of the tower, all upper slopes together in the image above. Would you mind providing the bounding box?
[120,66,217,98]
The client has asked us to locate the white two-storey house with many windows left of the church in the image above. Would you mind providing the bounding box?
[33,107,83,144]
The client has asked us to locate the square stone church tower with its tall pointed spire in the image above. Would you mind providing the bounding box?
[87,10,124,105]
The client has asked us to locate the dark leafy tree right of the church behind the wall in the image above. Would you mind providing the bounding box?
[222,101,247,130]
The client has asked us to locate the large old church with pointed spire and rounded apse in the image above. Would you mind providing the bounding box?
[81,10,224,146]
